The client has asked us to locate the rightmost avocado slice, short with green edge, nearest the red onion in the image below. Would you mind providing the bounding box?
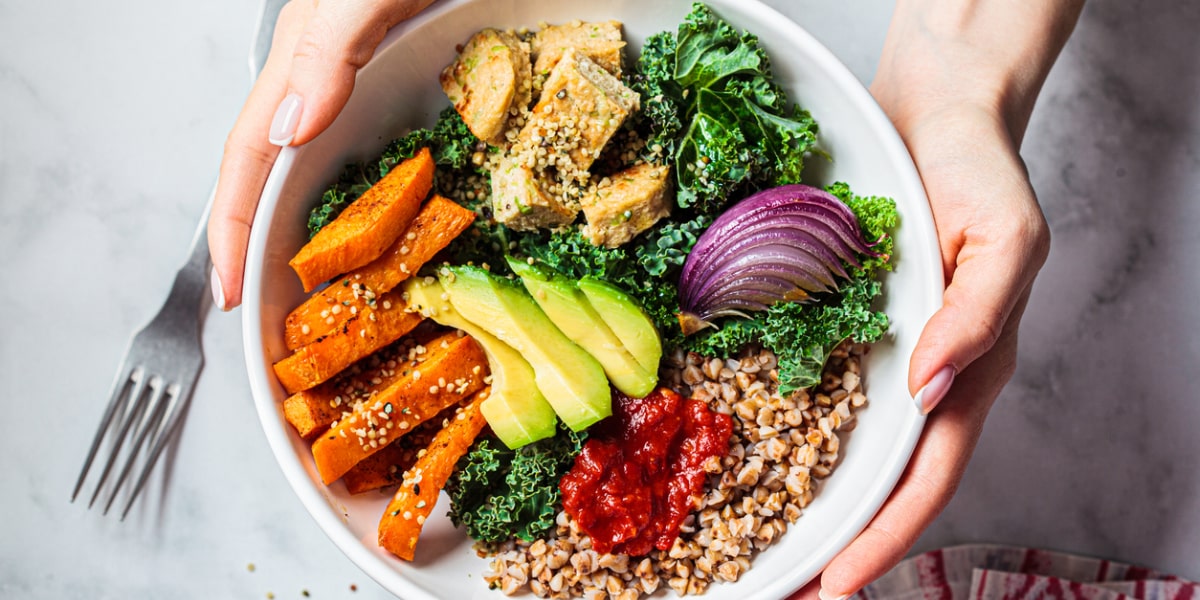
[578,276,662,376]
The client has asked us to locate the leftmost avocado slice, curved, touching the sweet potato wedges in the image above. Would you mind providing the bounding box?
[403,277,558,449]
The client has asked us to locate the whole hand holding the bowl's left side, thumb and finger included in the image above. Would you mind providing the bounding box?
[208,0,433,310]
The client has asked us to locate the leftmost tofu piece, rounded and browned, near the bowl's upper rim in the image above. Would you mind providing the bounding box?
[439,29,533,145]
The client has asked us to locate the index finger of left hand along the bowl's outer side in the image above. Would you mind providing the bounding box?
[208,2,312,310]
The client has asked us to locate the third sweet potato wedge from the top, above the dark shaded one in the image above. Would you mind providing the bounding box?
[275,290,421,394]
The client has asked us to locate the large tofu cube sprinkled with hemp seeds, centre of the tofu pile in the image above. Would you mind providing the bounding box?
[515,48,638,181]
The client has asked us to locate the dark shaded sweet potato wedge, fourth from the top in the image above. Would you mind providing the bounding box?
[283,322,444,440]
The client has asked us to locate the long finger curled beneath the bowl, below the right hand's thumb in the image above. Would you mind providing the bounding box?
[821,288,1030,599]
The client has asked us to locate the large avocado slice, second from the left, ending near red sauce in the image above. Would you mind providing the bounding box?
[438,266,612,431]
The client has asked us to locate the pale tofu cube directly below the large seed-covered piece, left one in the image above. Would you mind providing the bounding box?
[492,156,580,232]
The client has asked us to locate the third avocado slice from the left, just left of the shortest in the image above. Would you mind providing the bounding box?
[509,257,659,398]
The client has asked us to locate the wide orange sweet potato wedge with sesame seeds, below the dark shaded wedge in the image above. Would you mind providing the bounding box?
[312,331,490,485]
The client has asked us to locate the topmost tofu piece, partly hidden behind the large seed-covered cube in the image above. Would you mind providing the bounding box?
[529,20,625,78]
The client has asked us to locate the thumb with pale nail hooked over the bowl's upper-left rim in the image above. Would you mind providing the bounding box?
[270,0,432,145]
